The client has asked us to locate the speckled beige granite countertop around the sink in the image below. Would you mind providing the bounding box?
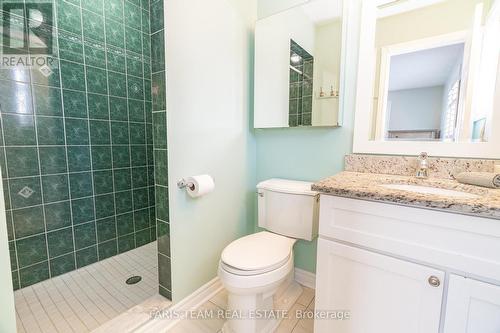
[312,171,500,220]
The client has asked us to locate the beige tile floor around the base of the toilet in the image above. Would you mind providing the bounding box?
[168,287,314,333]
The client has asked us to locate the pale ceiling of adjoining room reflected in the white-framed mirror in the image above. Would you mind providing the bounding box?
[389,43,464,91]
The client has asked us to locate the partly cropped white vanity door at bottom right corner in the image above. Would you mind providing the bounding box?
[444,275,500,333]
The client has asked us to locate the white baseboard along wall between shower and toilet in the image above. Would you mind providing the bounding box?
[134,277,224,333]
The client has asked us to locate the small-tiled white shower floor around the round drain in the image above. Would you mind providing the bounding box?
[15,242,158,333]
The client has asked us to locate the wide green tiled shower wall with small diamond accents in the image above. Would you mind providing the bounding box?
[0,0,157,289]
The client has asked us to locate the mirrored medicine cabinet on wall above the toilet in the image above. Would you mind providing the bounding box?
[254,0,345,128]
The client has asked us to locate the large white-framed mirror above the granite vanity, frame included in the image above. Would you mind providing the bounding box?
[354,0,500,158]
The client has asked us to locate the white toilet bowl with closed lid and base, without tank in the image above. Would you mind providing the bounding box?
[218,231,296,333]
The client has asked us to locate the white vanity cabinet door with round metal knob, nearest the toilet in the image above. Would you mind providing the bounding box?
[314,238,444,333]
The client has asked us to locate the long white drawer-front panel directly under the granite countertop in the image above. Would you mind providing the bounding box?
[319,195,500,281]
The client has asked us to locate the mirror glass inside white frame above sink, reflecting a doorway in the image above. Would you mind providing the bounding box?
[372,0,500,142]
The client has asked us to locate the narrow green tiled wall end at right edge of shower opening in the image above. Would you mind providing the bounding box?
[151,0,172,299]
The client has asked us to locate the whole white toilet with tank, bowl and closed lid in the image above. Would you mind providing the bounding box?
[218,179,319,333]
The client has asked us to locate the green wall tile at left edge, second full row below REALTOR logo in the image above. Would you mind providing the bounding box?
[2,114,36,146]
